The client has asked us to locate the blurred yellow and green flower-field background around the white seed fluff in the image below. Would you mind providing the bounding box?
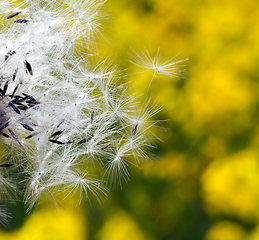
[0,0,259,240]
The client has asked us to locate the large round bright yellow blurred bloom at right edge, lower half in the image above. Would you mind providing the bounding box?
[201,149,259,220]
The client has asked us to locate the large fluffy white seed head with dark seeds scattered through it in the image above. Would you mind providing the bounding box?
[0,0,185,223]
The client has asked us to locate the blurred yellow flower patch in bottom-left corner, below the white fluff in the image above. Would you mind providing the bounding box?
[0,207,86,240]
